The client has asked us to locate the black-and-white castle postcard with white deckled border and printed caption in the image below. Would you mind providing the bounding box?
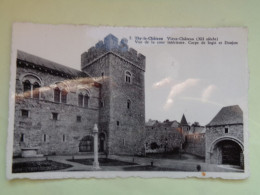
[7,23,249,179]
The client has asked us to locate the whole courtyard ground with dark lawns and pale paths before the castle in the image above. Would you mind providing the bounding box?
[13,153,243,173]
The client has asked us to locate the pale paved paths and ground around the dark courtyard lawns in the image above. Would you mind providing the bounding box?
[13,154,243,172]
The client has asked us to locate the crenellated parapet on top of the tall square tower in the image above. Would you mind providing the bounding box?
[81,34,145,71]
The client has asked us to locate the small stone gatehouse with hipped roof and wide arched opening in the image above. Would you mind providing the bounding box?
[205,105,244,168]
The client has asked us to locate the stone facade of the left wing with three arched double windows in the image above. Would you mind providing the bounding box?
[13,66,99,156]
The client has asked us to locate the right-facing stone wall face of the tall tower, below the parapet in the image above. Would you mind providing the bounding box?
[109,54,145,154]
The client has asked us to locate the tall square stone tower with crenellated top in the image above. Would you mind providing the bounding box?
[81,34,145,154]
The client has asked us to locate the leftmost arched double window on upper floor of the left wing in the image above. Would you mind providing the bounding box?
[19,72,43,99]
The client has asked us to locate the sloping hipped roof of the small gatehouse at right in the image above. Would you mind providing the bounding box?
[207,105,243,126]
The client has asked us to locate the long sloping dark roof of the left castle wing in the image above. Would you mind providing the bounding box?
[17,50,88,77]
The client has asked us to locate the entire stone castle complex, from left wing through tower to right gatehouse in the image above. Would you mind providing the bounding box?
[13,34,243,166]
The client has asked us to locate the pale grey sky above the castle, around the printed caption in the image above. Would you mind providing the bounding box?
[11,23,249,125]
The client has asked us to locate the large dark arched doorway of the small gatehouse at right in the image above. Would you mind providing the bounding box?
[211,139,243,166]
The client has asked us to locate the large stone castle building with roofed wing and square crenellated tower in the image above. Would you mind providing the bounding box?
[13,34,145,156]
